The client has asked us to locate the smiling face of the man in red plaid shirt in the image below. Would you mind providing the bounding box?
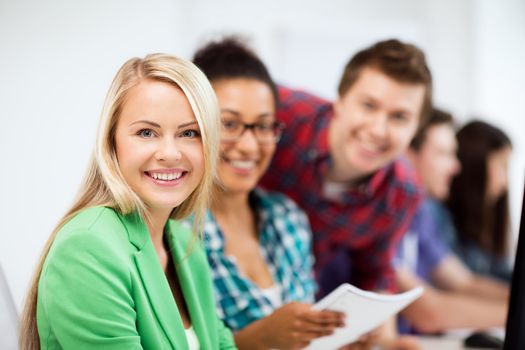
[329,68,425,181]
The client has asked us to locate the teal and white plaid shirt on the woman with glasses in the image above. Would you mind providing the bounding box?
[204,189,316,330]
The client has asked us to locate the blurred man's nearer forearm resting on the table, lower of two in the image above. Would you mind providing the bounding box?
[396,267,507,333]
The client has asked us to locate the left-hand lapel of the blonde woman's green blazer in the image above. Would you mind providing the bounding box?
[123,214,188,349]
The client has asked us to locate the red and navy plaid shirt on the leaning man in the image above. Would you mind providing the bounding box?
[261,87,422,296]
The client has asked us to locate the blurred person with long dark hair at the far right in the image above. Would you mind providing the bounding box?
[448,121,512,282]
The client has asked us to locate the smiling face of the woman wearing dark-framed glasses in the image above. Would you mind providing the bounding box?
[213,78,275,193]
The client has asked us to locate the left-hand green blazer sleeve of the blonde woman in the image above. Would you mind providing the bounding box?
[37,232,142,349]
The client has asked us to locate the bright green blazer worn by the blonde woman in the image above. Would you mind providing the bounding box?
[37,207,235,350]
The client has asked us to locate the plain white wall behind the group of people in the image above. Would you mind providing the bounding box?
[0,0,525,306]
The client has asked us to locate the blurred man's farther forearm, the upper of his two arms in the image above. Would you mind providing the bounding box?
[432,254,509,302]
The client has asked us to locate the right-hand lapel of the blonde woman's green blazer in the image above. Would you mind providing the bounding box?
[168,220,211,349]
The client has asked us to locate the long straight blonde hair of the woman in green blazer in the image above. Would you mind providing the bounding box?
[19,54,219,350]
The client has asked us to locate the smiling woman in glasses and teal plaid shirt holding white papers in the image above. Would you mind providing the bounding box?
[190,38,343,349]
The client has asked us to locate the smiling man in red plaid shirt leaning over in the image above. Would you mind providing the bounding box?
[262,40,432,295]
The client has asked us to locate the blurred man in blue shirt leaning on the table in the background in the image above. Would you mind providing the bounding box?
[395,108,508,333]
